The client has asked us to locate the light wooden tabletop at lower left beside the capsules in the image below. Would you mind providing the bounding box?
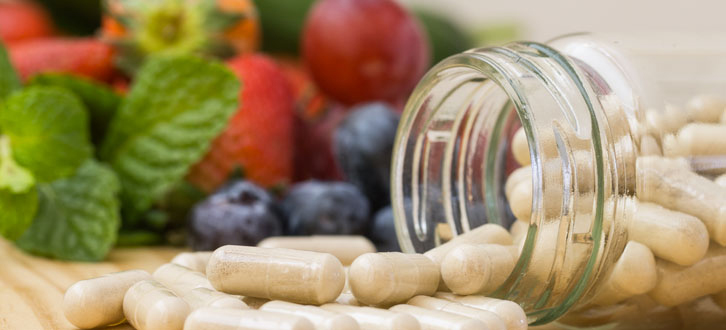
[0,238,182,330]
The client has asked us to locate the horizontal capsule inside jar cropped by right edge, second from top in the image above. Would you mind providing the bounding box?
[663,123,726,157]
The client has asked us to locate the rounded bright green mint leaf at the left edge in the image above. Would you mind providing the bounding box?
[0,87,92,182]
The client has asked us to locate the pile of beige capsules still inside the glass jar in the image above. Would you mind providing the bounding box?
[505,95,726,317]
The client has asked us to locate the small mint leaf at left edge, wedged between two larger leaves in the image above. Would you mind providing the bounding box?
[0,189,38,240]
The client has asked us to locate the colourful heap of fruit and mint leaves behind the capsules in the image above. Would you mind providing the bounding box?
[0,0,520,261]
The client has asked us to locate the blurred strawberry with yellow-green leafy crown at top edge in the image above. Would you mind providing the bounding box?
[101,0,259,72]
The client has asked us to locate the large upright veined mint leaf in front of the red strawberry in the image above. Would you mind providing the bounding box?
[100,56,240,223]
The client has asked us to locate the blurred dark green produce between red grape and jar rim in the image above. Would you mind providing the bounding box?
[414,9,474,64]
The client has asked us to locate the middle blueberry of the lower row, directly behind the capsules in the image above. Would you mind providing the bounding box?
[282,180,369,235]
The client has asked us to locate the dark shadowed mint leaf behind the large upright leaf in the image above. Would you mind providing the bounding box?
[29,73,122,144]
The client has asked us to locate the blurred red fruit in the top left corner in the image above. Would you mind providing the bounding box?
[0,1,53,44]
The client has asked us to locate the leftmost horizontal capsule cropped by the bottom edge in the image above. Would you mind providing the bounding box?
[184,307,315,330]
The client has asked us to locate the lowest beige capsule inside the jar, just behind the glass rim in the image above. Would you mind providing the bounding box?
[593,241,658,306]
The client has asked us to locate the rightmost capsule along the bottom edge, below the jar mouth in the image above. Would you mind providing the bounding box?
[434,292,527,330]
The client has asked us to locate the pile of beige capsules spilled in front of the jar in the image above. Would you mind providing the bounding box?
[63,232,527,330]
